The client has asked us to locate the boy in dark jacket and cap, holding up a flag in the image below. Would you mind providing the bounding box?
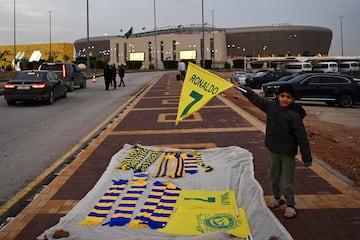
[240,84,312,218]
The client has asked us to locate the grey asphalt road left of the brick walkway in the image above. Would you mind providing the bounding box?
[0,72,161,206]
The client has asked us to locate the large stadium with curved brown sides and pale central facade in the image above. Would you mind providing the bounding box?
[74,24,332,69]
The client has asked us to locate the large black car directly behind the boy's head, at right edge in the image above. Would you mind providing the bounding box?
[262,73,360,107]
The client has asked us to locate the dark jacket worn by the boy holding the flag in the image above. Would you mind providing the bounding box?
[243,88,312,164]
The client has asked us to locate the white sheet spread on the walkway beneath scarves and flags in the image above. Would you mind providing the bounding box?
[38,144,292,240]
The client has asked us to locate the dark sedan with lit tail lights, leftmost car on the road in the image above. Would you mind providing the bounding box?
[4,70,67,105]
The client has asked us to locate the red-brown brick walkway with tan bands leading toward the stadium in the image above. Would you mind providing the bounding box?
[0,73,360,240]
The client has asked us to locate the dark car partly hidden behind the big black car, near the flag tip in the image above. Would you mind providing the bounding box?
[245,71,291,88]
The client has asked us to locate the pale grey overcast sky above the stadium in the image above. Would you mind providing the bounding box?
[0,0,360,56]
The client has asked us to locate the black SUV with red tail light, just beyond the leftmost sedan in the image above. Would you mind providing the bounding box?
[38,62,86,92]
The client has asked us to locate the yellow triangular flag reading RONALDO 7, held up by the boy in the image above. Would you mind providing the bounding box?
[175,62,233,125]
